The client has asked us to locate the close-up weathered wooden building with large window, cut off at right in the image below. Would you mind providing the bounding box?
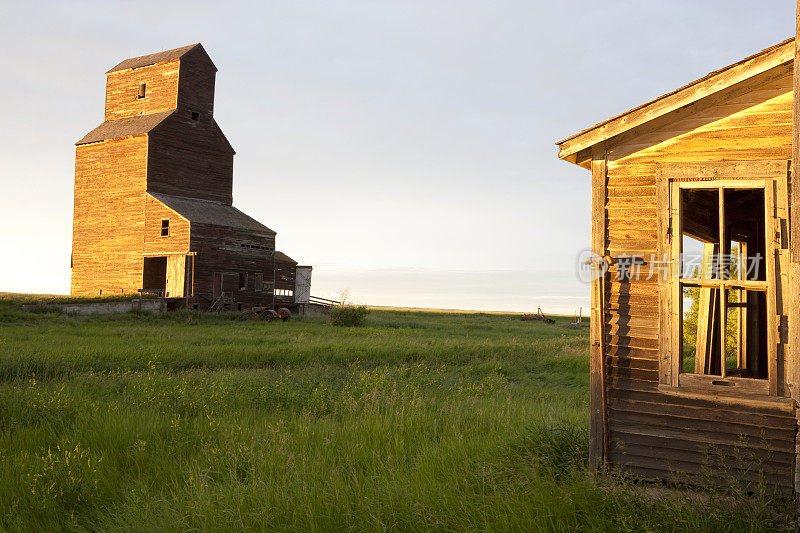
[557,39,800,493]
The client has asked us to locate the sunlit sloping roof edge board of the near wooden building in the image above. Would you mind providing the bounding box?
[556,37,794,158]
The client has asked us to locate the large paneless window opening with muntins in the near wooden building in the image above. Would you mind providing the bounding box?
[679,188,768,379]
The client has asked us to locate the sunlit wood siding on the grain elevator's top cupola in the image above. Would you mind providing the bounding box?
[105,59,180,120]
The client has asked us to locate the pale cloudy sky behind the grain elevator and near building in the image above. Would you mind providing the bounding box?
[0,0,795,314]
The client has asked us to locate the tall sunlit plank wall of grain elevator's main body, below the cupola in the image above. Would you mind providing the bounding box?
[71,135,147,295]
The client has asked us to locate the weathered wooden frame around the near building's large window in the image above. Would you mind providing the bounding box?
[656,161,789,400]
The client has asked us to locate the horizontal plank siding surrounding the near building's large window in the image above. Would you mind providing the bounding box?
[595,65,795,490]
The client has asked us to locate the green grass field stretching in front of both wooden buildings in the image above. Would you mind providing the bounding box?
[0,296,794,531]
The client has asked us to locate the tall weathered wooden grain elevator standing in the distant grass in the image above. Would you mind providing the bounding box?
[71,44,311,309]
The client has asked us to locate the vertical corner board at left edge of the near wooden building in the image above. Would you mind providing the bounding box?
[589,145,608,468]
